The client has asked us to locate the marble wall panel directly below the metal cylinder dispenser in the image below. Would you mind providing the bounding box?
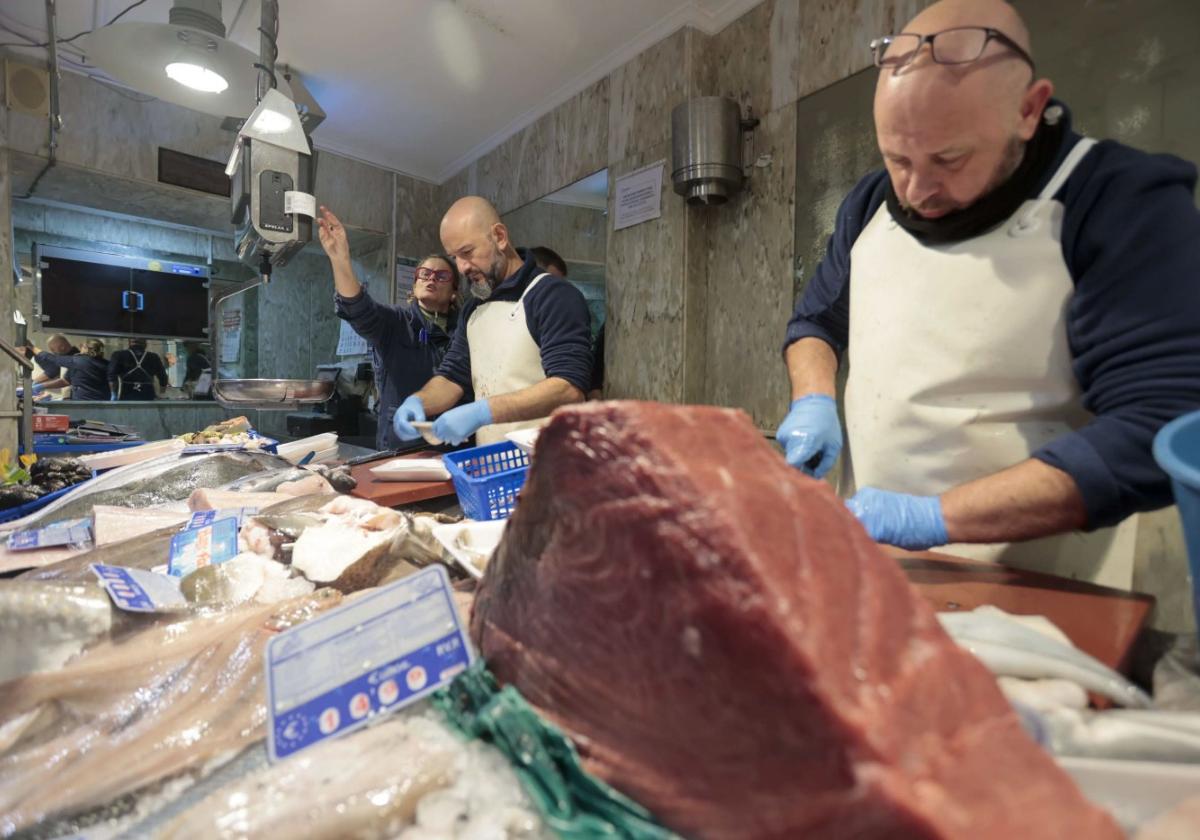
[689,106,796,428]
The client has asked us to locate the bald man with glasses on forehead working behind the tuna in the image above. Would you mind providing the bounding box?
[776,0,1200,586]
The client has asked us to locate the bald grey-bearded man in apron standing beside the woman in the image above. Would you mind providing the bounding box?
[392,196,592,444]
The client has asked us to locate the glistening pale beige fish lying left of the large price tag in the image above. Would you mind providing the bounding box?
[0,589,341,836]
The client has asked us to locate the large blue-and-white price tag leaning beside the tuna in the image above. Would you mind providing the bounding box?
[266,566,475,761]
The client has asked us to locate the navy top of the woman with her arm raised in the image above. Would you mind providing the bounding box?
[334,289,455,449]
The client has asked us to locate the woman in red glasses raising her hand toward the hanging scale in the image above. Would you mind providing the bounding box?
[317,206,458,450]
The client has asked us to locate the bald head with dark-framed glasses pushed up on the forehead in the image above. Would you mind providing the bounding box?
[875,0,1054,218]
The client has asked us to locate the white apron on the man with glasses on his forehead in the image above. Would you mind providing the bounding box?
[845,139,1136,588]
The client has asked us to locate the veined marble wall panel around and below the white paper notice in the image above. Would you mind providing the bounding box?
[605,142,688,402]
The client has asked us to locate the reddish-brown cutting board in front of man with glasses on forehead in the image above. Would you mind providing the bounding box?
[887,548,1154,674]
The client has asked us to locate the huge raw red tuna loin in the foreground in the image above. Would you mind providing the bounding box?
[472,403,1121,840]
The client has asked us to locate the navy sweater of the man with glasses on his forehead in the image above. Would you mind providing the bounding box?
[785,106,1200,528]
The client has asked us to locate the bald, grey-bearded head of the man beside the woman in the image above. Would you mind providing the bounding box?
[440,196,521,298]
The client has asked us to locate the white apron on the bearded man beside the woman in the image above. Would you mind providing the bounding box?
[467,272,550,446]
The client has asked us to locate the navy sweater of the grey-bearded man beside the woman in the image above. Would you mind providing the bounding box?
[438,248,592,394]
